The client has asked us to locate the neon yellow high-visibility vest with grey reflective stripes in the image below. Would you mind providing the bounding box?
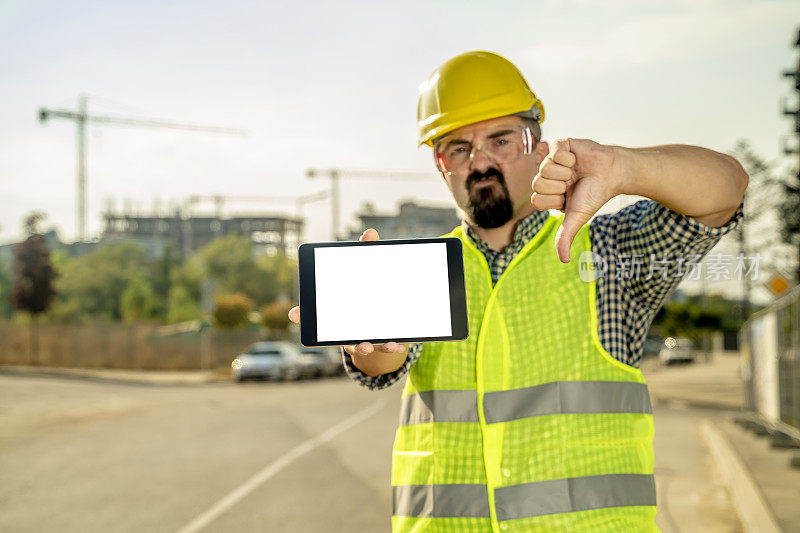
[391,214,659,533]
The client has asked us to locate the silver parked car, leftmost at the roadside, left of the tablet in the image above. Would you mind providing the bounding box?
[231,341,303,382]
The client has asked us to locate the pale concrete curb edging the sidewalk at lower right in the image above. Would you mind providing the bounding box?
[700,419,781,533]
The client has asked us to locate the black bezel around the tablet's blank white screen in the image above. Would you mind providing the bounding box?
[297,237,469,347]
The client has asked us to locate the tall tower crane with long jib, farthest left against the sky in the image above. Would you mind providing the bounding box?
[39,95,247,241]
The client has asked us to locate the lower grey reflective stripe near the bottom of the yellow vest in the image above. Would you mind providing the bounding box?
[392,474,656,520]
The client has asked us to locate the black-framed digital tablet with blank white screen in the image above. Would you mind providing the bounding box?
[298,237,469,346]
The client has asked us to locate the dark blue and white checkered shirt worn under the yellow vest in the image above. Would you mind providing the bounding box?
[342,199,743,390]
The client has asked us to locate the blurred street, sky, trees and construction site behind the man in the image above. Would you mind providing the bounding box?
[0,0,800,532]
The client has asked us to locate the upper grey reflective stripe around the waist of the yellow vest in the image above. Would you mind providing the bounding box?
[400,381,653,425]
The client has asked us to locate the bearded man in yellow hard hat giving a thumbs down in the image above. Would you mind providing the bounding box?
[290,48,748,533]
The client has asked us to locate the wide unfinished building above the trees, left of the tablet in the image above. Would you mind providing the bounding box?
[101,209,304,257]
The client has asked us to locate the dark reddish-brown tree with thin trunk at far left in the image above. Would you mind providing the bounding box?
[9,234,56,362]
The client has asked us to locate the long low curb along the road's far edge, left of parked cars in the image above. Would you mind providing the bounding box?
[0,365,230,386]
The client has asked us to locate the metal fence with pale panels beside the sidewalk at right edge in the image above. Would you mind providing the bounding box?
[740,287,800,441]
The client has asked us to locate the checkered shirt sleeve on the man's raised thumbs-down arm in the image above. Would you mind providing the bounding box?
[593,199,744,313]
